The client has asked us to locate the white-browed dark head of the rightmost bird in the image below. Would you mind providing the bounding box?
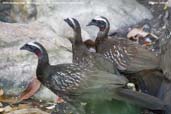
[87,16,110,32]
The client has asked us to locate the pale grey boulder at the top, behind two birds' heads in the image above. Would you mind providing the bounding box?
[36,0,152,37]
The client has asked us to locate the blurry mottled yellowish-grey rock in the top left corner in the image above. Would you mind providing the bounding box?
[0,0,37,23]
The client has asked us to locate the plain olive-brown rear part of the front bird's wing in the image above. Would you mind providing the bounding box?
[85,69,128,88]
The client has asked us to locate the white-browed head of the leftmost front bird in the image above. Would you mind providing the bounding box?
[20,42,44,58]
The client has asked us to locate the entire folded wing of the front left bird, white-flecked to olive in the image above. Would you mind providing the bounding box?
[51,66,128,98]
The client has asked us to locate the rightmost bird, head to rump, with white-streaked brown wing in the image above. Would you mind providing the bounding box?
[87,16,160,73]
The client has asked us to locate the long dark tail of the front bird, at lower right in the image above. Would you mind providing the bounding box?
[114,88,166,110]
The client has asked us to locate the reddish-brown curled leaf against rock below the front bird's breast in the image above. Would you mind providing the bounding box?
[18,77,41,101]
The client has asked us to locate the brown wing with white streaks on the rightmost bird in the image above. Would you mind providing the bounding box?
[98,39,159,72]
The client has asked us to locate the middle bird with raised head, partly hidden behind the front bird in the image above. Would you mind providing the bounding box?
[64,18,167,112]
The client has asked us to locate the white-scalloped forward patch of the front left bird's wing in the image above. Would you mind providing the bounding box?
[49,64,84,93]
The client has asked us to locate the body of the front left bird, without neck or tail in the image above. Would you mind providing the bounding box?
[43,64,127,99]
